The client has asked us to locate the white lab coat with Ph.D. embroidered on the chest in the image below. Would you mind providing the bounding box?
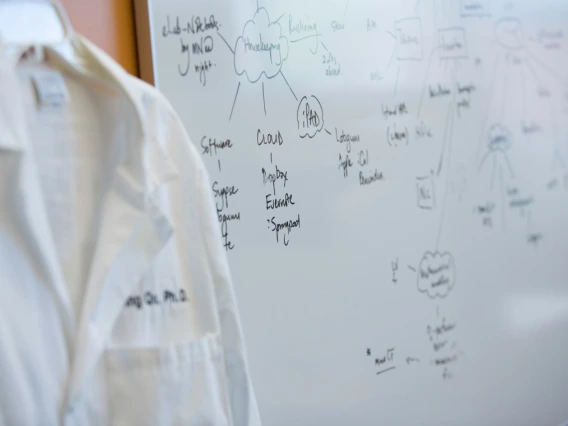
[0,36,260,426]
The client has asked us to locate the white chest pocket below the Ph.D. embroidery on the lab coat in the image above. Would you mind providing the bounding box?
[105,334,230,426]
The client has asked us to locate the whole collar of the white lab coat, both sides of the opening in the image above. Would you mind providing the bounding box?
[0,35,177,407]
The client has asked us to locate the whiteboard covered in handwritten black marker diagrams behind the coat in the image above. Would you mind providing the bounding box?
[134,0,568,426]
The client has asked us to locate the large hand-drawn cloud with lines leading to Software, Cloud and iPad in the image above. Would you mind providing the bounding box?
[235,7,288,83]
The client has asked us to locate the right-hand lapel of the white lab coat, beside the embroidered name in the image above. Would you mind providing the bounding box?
[62,40,177,405]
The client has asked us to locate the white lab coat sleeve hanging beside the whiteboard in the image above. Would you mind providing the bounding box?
[193,161,261,426]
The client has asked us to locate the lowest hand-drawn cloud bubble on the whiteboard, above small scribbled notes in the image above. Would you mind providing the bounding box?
[418,252,456,299]
